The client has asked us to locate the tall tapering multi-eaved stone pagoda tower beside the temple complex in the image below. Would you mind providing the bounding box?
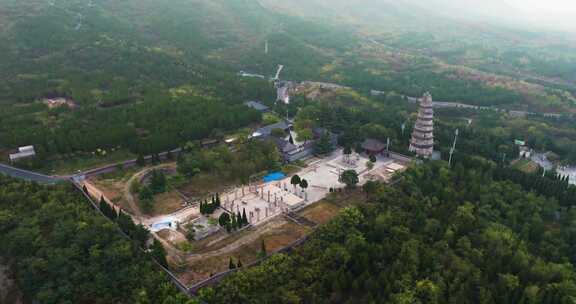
[409,92,434,158]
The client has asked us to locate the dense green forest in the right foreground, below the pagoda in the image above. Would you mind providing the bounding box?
[201,159,576,303]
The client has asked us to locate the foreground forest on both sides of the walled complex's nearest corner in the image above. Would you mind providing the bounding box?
[0,157,576,303]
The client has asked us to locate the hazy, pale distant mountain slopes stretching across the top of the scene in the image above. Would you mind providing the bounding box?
[0,0,576,110]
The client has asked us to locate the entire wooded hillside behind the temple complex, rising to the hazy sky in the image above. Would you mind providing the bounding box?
[0,0,576,169]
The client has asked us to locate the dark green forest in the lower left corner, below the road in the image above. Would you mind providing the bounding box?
[0,176,198,304]
